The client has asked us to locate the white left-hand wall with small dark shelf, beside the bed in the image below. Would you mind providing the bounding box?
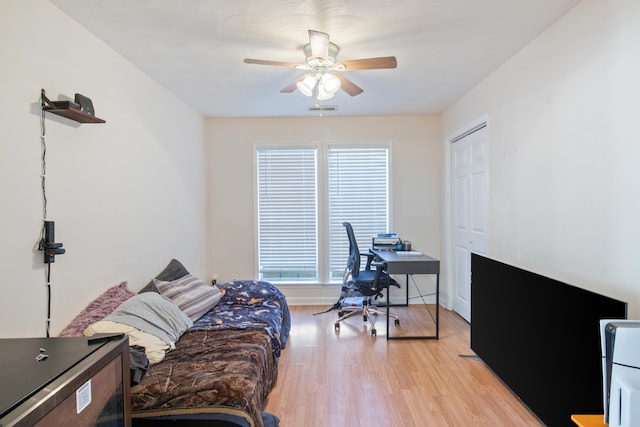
[0,0,206,337]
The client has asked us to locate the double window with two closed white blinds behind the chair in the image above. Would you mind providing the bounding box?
[256,144,389,283]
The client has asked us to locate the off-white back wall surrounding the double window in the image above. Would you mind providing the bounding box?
[205,116,442,304]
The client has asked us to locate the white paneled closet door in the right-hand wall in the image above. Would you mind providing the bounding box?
[451,125,489,322]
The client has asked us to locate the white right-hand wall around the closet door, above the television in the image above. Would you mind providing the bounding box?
[443,0,640,318]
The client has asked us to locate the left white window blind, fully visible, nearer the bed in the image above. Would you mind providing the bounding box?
[257,148,318,282]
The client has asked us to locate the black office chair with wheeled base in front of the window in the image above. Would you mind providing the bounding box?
[335,222,400,336]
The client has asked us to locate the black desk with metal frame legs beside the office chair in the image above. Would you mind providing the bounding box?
[371,248,440,340]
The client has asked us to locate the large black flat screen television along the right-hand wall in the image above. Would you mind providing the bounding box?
[471,254,627,427]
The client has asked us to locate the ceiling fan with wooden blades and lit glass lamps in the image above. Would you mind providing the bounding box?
[244,30,398,100]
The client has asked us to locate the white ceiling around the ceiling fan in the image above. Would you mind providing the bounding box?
[51,0,580,117]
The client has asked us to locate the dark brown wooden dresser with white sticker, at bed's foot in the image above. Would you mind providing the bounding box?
[0,335,131,427]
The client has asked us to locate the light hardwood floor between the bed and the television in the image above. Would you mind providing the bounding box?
[265,306,542,427]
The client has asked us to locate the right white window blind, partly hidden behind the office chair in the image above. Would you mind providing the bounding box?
[327,146,389,281]
